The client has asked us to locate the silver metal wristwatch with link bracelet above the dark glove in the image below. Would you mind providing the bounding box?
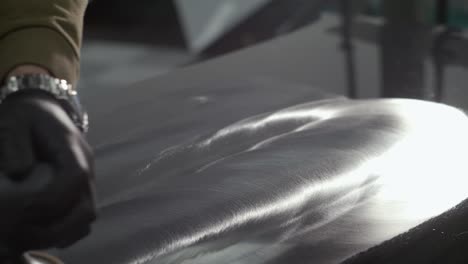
[0,74,89,133]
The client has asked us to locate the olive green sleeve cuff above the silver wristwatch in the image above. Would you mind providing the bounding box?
[0,0,88,84]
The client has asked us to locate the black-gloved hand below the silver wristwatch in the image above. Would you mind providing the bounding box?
[0,90,96,256]
